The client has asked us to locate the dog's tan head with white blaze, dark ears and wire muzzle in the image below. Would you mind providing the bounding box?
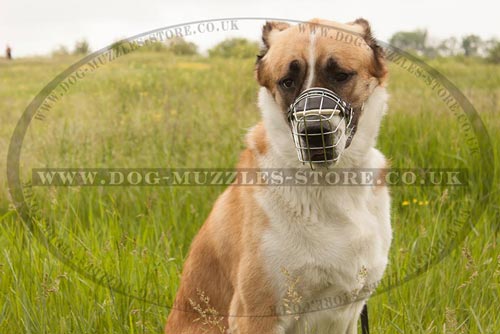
[256,19,387,166]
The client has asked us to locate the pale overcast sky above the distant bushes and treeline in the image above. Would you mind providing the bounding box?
[0,0,500,56]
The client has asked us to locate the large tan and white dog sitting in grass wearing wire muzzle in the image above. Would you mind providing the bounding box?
[165,19,392,334]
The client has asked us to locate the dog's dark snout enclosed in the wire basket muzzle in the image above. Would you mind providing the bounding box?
[288,88,354,166]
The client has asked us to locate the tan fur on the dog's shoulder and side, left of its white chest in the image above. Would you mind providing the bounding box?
[165,149,277,334]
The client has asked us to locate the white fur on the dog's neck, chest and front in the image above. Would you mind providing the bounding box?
[256,87,392,334]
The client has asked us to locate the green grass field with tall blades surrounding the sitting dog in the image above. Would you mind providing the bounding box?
[0,52,500,334]
